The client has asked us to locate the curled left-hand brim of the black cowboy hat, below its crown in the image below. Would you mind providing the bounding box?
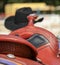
[4,16,28,30]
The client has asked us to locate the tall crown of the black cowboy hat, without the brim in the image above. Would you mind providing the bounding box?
[15,7,33,24]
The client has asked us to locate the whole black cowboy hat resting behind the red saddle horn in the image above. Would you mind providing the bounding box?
[4,7,43,30]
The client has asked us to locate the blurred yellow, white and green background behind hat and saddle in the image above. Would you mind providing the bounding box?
[0,0,60,37]
